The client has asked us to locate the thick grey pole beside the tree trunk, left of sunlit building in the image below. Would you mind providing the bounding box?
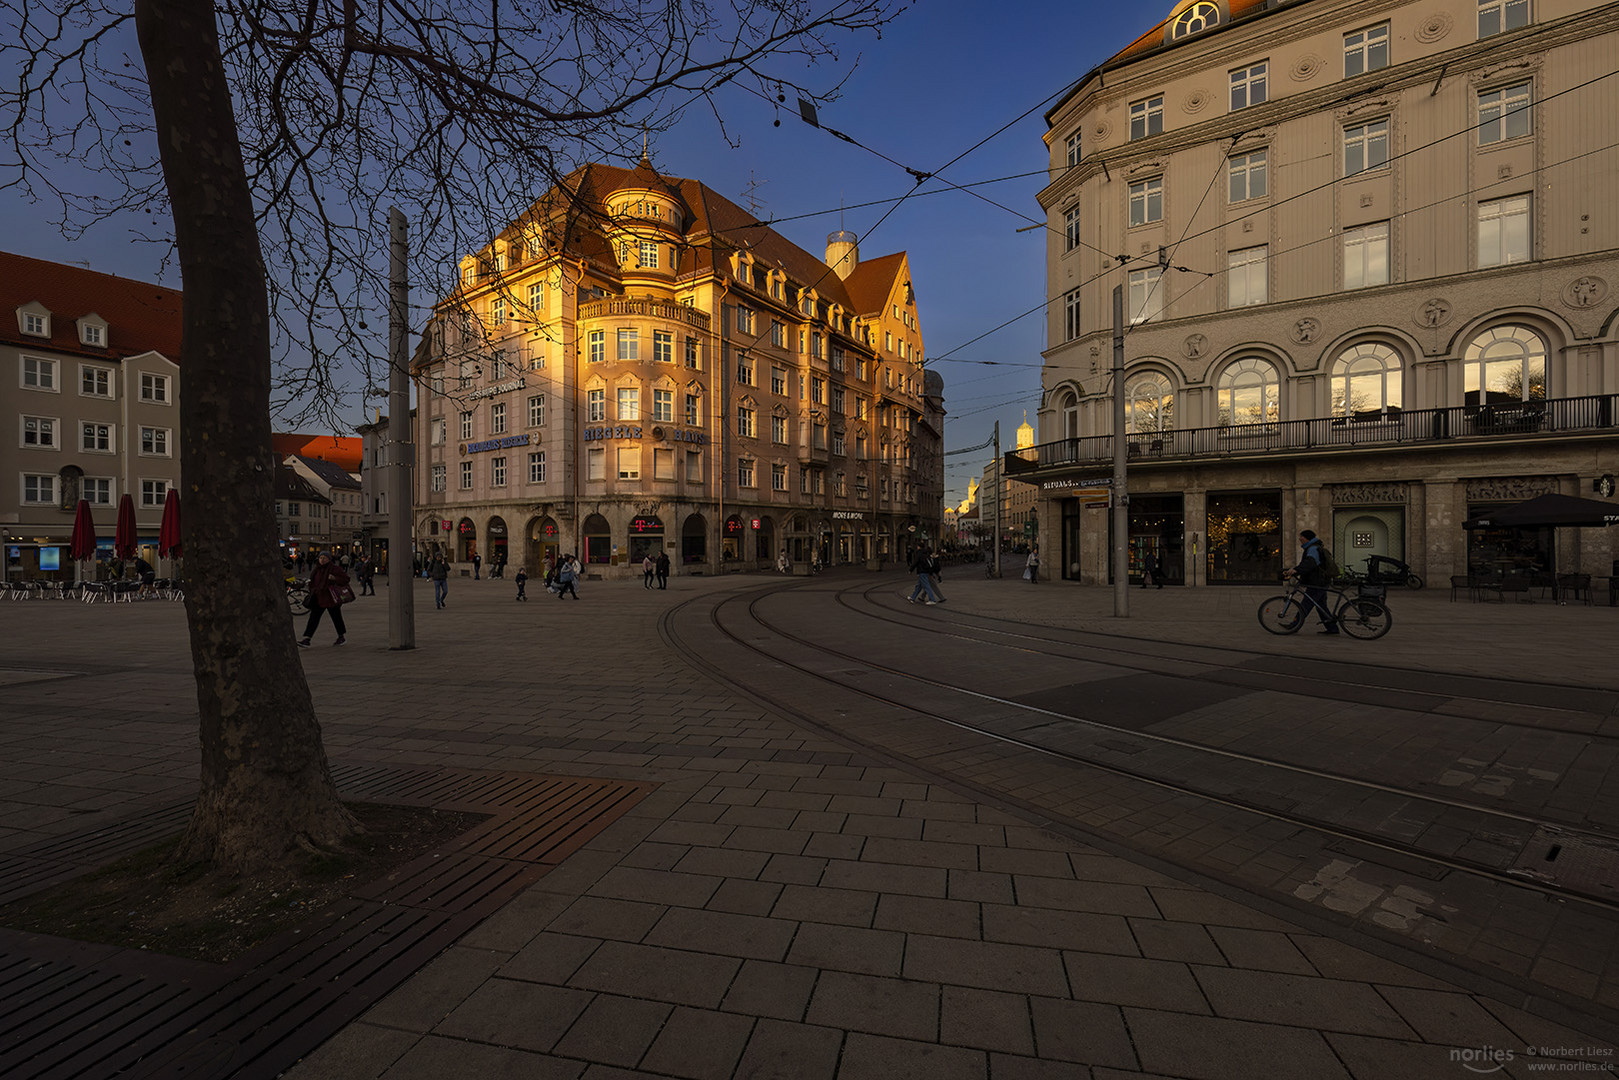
[387,207,416,649]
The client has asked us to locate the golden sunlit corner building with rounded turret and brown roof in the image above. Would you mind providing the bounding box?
[413,159,944,576]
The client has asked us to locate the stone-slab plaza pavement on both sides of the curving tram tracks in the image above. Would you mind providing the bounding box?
[0,572,1619,1080]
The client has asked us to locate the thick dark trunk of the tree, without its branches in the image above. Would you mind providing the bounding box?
[134,0,356,873]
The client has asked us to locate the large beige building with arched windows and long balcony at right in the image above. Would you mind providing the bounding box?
[1007,0,1619,585]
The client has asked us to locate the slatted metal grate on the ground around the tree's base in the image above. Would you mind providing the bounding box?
[0,766,654,1080]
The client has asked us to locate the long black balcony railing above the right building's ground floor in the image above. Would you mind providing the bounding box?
[1005,393,1619,474]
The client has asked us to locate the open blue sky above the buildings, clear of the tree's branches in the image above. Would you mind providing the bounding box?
[0,0,1172,504]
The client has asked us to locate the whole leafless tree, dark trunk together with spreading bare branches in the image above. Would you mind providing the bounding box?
[0,0,903,871]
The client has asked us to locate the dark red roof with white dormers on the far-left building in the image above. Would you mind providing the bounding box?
[0,251,181,364]
